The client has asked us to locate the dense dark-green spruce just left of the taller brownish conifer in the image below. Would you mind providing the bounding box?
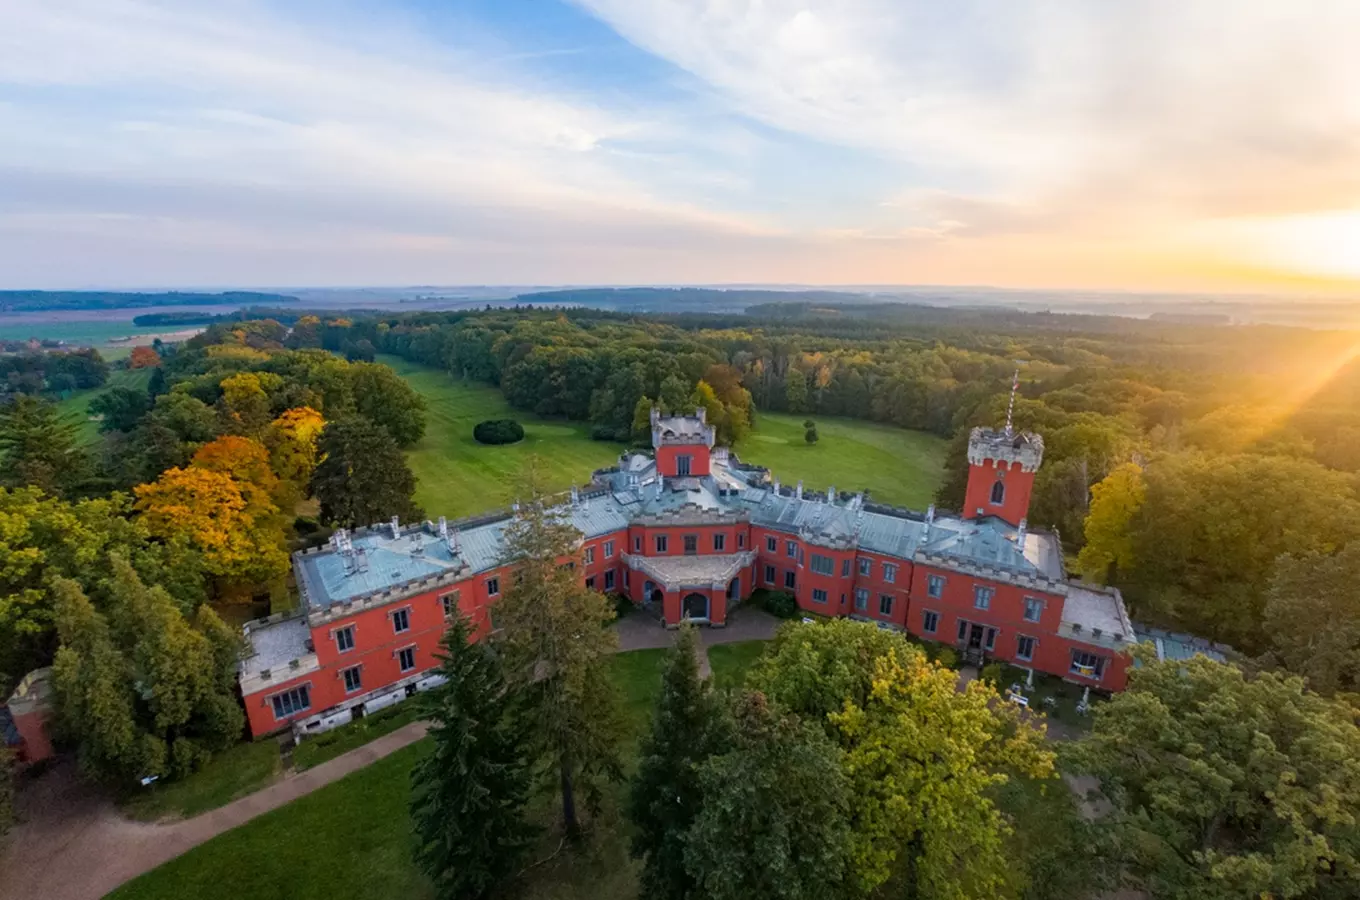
[411,615,536,900]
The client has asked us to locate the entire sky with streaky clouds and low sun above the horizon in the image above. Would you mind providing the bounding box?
[0,0,1360,296]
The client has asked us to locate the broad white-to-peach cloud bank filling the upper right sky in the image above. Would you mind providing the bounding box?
[578,0,1360,232]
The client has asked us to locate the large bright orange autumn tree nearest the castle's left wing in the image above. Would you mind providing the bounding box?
[135,465,288,590]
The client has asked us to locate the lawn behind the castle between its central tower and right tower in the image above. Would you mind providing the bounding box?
[736,412,947,510]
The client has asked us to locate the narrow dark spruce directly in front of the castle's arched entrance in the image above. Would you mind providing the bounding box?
[628,625,733,900]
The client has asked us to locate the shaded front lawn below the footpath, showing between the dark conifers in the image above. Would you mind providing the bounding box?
[110,650,665,900]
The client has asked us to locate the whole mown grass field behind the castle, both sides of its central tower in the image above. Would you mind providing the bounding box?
[381,356,945,518]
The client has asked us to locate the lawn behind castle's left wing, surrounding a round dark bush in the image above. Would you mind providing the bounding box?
[379,356,623,518]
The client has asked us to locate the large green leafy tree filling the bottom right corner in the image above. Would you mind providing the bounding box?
[1072,654,1360,900]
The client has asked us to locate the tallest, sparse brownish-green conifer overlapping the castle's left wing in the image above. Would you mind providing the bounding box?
[496,460,623,839]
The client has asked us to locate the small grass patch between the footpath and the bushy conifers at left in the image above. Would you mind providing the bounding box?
[122,740,280,820]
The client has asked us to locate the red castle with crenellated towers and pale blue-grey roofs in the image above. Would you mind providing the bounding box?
[241,409,1136,735]
